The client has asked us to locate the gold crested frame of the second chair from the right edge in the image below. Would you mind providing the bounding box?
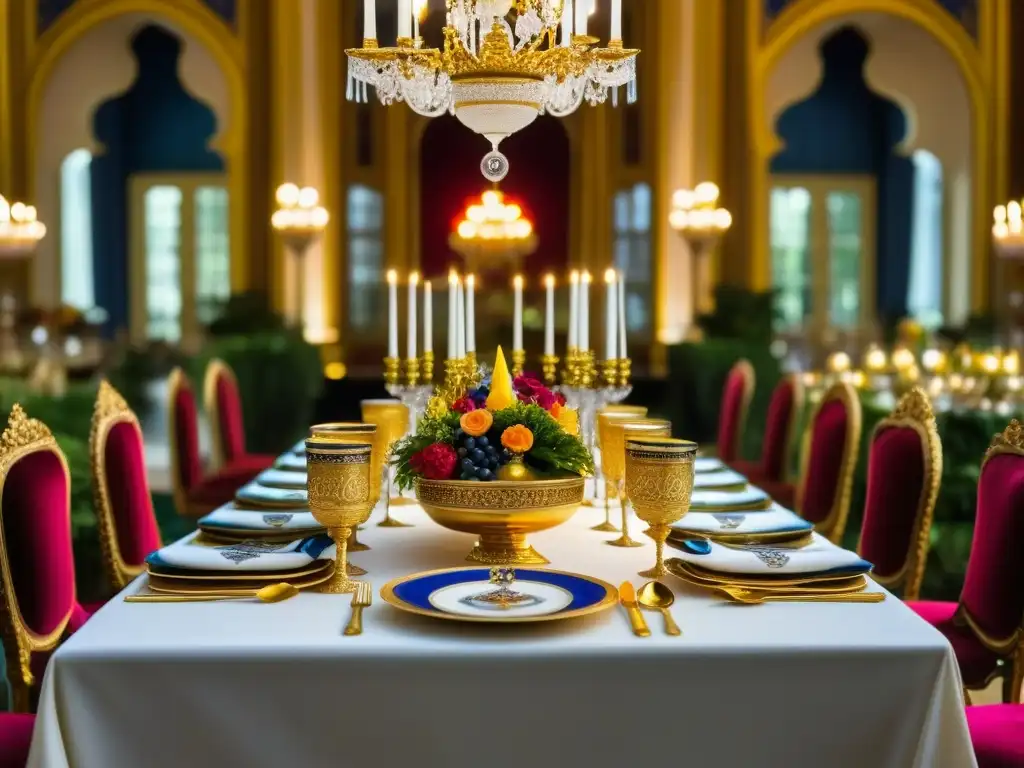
[857,387,942,600]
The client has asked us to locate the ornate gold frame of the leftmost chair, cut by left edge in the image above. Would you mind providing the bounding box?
[0,402,77,713]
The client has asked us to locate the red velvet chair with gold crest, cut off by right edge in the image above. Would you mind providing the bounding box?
[908,419,1024,703]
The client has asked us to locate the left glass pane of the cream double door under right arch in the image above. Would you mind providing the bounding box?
[771,187,811,330]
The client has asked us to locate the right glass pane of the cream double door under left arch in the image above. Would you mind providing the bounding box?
[195,186,231,326]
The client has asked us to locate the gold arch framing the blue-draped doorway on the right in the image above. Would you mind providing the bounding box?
[748,0,996,310]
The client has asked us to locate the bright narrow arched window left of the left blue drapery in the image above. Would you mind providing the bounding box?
[60,150,96,310]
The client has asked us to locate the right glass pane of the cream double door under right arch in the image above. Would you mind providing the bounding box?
[825,191,863,329]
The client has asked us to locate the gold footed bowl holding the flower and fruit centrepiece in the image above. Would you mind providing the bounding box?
[416,477,584,565]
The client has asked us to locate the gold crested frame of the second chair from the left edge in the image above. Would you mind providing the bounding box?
[89,379,160,592]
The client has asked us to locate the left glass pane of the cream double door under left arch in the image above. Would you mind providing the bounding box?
[143,186,181,342]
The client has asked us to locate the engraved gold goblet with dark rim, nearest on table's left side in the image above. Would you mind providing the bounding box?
[306,437,374,595]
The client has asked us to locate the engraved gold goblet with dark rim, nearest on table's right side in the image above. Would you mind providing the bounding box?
[626,436,697,579]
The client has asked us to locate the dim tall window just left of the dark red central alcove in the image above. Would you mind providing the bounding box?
[347,184,384,331]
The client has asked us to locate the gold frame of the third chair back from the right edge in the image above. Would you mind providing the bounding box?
[796,381,863,544]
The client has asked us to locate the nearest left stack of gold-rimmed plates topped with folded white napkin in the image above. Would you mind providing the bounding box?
[146,534,334,595]
